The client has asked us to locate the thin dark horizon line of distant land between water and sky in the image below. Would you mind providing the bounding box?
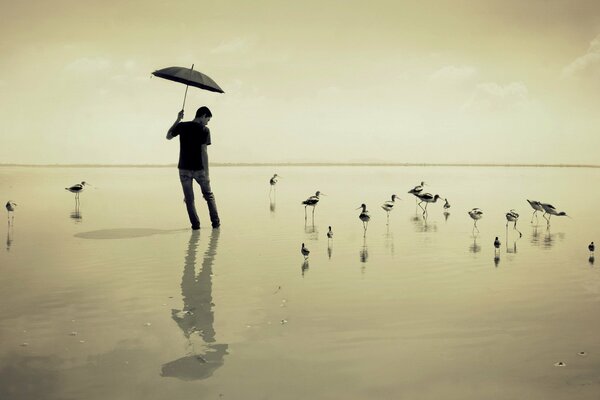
[0,162,600,168]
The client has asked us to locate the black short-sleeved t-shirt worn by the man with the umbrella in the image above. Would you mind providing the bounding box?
[172,121,210,171]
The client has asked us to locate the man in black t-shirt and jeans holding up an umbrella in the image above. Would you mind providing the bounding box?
[167,106,221,230]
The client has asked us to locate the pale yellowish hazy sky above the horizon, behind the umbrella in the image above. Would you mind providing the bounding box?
[0,0,600,164]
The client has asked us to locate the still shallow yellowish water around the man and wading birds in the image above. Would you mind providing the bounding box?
[0,167,600,399]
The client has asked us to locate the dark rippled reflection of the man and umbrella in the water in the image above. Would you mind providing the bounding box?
[161,229,228,381]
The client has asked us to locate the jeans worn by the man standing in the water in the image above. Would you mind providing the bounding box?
[179,169,221,228]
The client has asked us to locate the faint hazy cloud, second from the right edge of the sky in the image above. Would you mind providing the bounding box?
[463,82,531,111]
